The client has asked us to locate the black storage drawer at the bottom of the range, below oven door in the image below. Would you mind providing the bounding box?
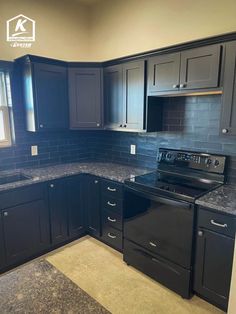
[124,239,190,298]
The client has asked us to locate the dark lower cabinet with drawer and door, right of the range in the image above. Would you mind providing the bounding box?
[194,209,235,310]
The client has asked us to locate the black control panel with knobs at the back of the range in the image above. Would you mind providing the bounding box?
[157,148,226,174]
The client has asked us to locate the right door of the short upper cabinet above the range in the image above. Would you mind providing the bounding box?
[180,45,221,89]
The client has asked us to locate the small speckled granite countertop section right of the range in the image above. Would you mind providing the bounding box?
[196,185,236,216]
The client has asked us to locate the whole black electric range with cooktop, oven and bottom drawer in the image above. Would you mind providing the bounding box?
[123,149,226,298]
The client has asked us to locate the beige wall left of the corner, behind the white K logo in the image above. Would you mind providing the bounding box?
[0,0,88,60]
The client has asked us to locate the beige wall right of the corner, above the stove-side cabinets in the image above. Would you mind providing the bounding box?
[90,0,236,60]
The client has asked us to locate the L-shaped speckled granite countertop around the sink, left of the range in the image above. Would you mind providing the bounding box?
[0,162,152,192]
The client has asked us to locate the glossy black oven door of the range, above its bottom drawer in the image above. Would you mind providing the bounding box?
[124,187,194,269]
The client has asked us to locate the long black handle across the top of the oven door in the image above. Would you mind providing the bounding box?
[125,186,193,209]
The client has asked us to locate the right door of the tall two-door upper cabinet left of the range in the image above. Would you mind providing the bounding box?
[123,61,145,130]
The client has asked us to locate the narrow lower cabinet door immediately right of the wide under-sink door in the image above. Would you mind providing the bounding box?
[49,179,68,244]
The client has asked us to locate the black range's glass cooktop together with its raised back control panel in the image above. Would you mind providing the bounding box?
[125,149,226,203]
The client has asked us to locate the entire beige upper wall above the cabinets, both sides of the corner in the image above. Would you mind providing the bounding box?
[0,0,236,61]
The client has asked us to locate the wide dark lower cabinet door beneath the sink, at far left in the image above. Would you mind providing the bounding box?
[2,200,50,265]
